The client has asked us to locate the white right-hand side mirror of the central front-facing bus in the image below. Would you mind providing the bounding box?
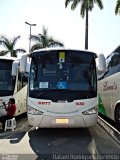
[97,54,106,74]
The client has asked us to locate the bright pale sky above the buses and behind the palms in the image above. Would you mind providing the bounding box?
[0,0,120,57]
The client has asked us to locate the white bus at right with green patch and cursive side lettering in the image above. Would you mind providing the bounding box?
[98,46,120,130]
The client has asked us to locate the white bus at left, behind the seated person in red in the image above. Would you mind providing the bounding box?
[0,56,28,117]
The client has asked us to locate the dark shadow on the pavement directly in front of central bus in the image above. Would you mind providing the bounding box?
[28,128,92,160]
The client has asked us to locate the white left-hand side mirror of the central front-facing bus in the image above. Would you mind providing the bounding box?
[20,54,30,73]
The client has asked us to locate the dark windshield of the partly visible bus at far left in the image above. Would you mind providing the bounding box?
[0,60,15,96]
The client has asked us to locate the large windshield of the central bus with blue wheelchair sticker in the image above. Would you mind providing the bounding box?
[29,50,97,100]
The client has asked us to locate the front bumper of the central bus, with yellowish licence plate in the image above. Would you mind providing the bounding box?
[28,113,98,128]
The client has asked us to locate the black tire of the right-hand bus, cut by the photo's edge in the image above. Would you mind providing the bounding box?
[115,105,120,131]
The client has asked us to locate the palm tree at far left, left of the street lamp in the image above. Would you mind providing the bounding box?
[0,36,26,57]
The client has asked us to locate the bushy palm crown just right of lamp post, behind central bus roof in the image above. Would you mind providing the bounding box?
[30,26,64,51]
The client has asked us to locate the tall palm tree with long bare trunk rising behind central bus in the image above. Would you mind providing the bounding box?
[65,0,103,49]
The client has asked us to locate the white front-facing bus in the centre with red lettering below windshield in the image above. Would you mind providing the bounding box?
[20,49,104,128]
